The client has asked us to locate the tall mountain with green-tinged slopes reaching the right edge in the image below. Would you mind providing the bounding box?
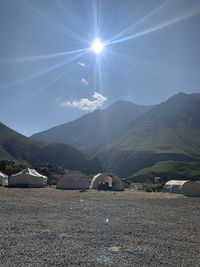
[99,93,200,179]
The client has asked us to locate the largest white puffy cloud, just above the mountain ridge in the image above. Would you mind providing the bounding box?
[62,92,107,111]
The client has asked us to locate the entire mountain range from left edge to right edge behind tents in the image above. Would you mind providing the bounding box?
[0,93,200,180]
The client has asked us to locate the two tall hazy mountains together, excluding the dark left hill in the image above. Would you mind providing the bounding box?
[32,93,200,179]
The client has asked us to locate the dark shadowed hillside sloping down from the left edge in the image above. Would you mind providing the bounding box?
[0,123,101,174]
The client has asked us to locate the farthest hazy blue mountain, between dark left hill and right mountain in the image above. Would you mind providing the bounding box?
[31,101,151,155]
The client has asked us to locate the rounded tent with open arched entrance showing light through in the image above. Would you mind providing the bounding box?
[90,173,123,191]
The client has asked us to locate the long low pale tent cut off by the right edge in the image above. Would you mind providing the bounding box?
[164,180,200,197]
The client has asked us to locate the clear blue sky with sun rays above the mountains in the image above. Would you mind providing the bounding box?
[0,0,200,135]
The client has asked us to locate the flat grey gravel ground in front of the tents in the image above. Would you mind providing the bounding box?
[0,187,200,267]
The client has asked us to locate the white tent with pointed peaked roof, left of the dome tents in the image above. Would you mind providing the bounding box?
[8,168,47,187]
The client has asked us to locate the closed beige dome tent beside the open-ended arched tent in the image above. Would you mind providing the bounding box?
[56,171,89,190]
